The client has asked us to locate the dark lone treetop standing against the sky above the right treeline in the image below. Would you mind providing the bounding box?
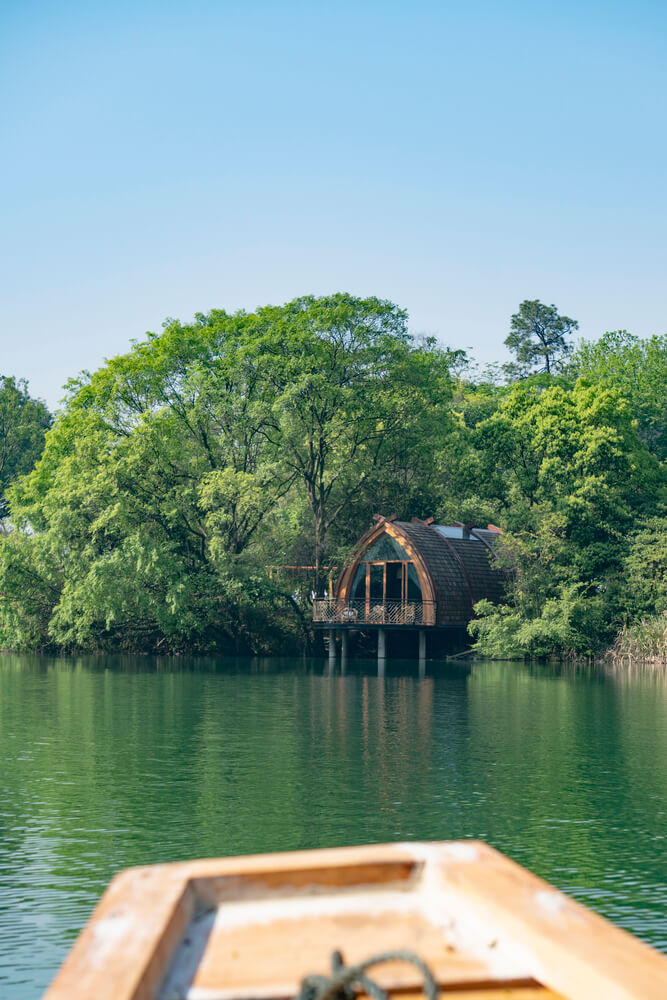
[504,299,579,375]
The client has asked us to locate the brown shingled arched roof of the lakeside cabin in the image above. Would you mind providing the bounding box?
[336,518,504,625]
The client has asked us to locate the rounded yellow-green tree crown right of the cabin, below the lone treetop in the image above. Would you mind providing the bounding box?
[475,380,658,528]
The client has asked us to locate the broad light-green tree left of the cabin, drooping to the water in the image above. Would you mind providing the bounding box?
[0,313,298,650]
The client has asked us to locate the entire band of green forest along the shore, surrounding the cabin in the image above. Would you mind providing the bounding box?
[0,294,667,657]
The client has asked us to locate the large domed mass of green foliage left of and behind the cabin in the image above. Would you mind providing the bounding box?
[0,295,454,651]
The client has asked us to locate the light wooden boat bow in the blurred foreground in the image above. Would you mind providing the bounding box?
[44,841,667,1000]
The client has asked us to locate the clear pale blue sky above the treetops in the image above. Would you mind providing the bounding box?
[0,0,667,406]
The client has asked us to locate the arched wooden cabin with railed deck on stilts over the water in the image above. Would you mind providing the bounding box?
[313,517,503,658]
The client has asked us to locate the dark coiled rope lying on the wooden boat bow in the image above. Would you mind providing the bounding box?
[294,951,438,1000]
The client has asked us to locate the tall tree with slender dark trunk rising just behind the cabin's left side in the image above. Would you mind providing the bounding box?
[248,293,459,592]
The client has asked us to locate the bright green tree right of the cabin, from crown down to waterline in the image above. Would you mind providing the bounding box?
[471,379,666,656]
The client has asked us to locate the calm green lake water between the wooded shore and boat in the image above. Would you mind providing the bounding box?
[0,655,667,1000]
